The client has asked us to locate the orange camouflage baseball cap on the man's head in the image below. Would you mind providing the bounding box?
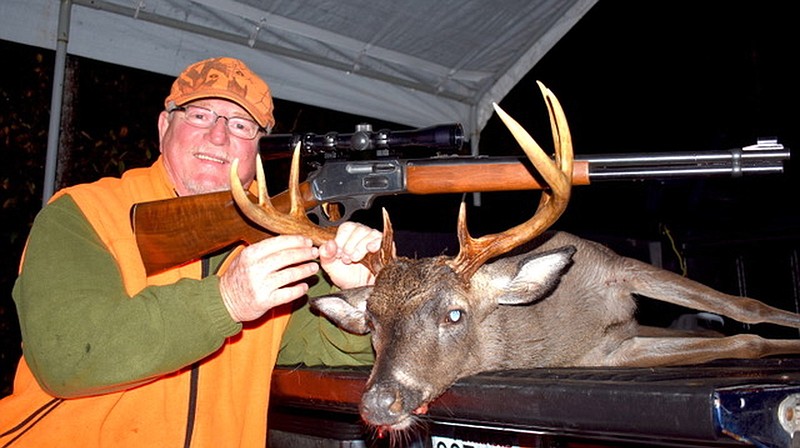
[164,57,275,129]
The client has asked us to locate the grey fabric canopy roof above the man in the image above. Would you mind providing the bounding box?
[0,0,597,138]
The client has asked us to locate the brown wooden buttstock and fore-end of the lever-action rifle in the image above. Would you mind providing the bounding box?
[131,159,589,275]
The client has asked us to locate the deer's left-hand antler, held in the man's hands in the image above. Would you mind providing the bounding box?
[230,143,394,275]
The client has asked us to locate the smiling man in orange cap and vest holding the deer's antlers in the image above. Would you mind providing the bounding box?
[0,58,381,448]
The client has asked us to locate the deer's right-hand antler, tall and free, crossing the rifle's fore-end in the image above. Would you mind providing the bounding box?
[451,81,573,279]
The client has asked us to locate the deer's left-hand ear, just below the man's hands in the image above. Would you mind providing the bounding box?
[310,286,372,334]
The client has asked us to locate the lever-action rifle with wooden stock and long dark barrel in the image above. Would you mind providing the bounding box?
[131,125,790,274]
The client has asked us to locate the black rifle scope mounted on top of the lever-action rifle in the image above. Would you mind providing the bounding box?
[259,123,464,157]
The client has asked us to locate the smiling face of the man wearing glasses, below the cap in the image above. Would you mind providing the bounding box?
[158,99,258,196]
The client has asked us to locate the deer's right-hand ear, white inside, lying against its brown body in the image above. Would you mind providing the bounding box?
[497,246,575,305]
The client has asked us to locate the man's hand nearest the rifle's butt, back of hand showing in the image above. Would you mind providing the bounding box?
[219,234,320,322]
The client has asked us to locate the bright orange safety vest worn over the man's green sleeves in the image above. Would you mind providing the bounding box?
[0,158,289,448]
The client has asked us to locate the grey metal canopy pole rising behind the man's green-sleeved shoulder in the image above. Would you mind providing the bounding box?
[42,0,72,206]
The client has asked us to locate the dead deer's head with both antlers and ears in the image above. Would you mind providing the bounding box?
[231,83,574,430]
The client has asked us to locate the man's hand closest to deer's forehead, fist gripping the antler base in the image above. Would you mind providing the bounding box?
[319,221,383,289]
